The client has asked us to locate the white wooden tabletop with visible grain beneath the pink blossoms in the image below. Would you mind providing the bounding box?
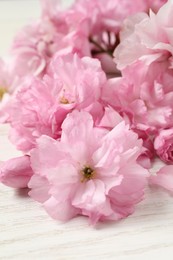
[0,0,173,260]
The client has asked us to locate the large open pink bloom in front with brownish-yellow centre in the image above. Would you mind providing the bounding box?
[29,111,148,224]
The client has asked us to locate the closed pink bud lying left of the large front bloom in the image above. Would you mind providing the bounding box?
[0,156,33,188]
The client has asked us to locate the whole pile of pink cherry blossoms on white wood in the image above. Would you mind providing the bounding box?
[0,0,173,225]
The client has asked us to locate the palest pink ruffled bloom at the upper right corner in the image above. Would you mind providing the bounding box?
[114,1,173,70]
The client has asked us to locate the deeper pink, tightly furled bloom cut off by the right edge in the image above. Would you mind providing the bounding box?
[154,128,173,164]
